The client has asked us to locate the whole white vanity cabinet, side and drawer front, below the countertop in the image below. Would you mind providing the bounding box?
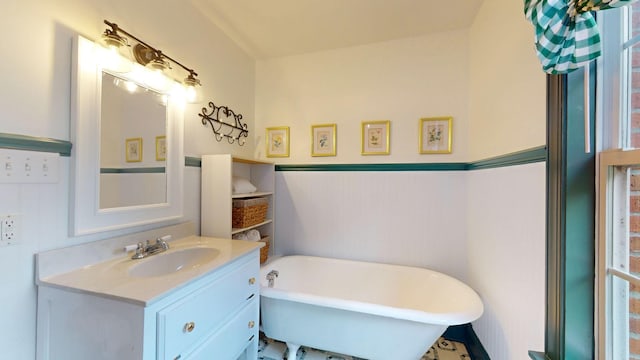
[37,248,260,360]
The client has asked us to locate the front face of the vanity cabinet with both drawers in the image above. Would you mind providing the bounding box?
[157,255,259,360]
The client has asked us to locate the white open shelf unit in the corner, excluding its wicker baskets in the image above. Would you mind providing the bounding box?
[200,154,275,253]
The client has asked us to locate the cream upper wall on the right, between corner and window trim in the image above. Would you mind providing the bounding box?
[466,0,546,161]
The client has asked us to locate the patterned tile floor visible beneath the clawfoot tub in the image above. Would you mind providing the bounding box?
[258,334,471,360]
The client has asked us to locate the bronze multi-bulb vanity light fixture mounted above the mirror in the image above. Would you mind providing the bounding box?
[102,20,201,101]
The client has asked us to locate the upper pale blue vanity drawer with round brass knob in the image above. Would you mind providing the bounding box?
[157,257,260,360]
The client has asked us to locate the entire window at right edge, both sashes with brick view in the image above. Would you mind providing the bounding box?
[596,3,640,359]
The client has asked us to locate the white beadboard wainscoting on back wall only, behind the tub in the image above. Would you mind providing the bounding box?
[274,171,467,281]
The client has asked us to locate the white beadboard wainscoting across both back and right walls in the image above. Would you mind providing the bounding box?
[274,162,546,360]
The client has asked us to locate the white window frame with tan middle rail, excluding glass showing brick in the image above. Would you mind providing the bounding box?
[595,7,640,360]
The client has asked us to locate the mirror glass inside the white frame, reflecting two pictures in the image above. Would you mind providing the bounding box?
[98,70,167,209]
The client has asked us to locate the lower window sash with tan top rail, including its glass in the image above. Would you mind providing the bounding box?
[597,149,640,359]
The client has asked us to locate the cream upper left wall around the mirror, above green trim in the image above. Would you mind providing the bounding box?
[0,0,254,156]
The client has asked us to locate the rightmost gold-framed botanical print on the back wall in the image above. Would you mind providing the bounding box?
[420,116,453,154]
